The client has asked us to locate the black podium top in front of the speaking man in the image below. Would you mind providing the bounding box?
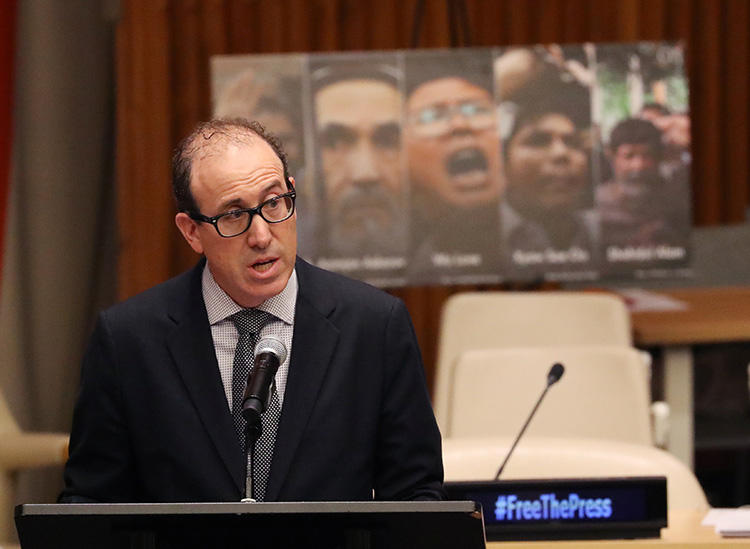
[15,501,485,549]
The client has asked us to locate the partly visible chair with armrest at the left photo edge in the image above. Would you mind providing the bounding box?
[0,392,68,548]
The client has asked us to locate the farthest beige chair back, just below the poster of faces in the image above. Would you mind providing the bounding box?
[434,292,633,427]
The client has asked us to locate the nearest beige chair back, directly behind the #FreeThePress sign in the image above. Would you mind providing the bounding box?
[443,437,709,512]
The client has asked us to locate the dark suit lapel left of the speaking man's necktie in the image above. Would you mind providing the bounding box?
[167,261,245,494]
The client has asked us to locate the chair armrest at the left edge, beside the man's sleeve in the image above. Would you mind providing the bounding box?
[0,433,68,471]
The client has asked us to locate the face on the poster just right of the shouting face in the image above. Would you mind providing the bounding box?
[506,113,588,215]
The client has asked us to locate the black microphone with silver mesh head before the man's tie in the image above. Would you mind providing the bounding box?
[242,336,287,440]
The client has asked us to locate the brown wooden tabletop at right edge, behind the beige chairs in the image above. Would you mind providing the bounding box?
[631,286,750,345]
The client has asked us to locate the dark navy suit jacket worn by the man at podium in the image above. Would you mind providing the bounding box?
[60,259,443,502]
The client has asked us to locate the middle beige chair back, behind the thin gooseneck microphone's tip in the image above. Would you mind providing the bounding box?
[442,346,652,446]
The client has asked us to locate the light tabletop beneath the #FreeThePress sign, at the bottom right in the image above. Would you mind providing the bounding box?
[487,510,750,549]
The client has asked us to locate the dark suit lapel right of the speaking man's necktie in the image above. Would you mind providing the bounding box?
[266,259,339,501]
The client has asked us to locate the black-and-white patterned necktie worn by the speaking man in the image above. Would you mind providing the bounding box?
[231,309,281,501]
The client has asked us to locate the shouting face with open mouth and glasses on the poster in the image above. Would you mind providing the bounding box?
[406,77,502,207]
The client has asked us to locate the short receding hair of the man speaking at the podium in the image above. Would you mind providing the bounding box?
[172,118,289,213]
